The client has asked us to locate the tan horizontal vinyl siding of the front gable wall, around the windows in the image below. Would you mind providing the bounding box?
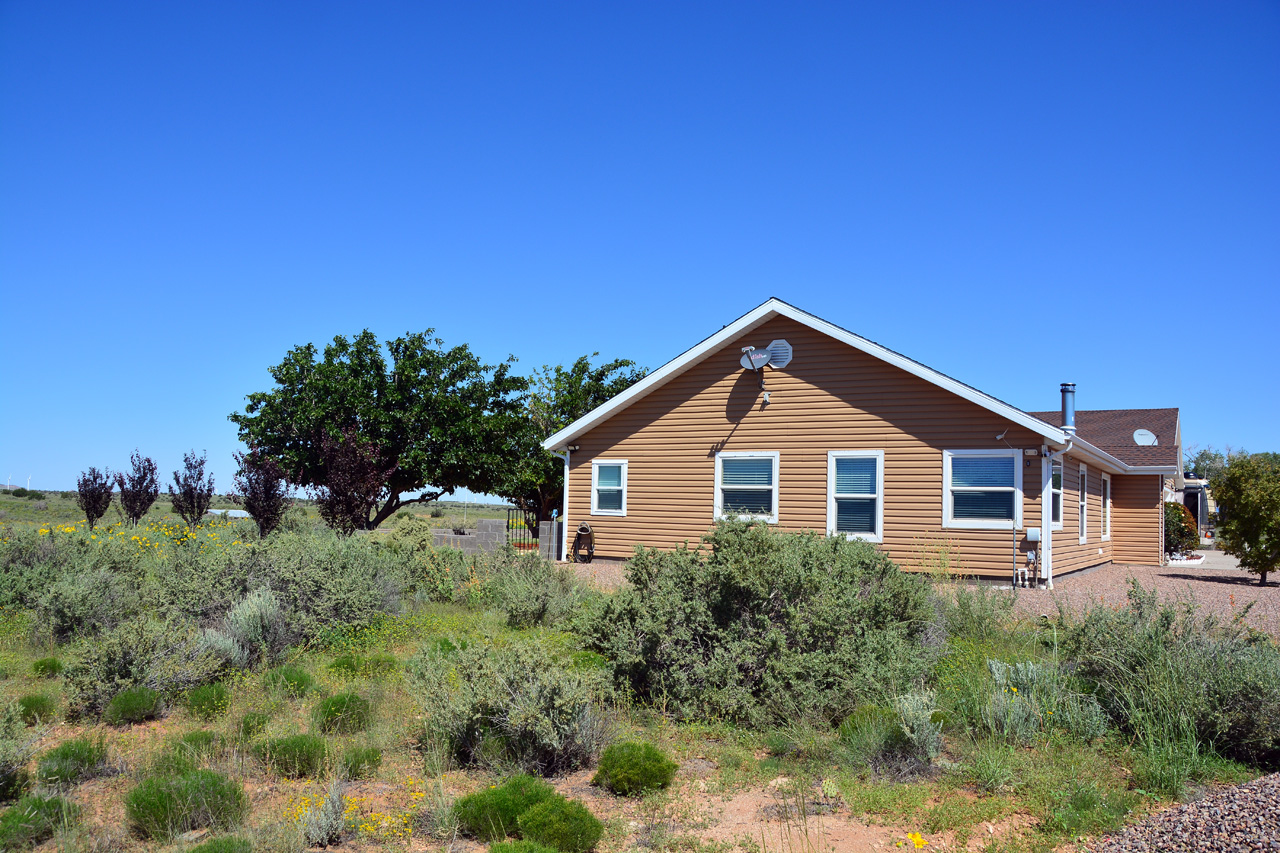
[566,318,1042,578]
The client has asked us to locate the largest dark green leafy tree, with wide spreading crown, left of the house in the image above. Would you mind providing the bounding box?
[229,329,527,529]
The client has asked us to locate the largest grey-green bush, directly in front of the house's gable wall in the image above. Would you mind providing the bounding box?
[588,521,934,724]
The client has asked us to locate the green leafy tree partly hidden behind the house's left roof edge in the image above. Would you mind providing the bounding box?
[493,352,648,525]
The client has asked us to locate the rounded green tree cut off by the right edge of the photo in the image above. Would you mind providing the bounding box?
[1210,452,1280,584]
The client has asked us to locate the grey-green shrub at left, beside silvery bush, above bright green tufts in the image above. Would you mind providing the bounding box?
[63,620,220,719]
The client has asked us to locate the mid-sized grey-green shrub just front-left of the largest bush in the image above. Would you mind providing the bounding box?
[410,643,608,775]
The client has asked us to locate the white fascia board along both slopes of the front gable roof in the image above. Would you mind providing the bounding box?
[543,298,1070,448]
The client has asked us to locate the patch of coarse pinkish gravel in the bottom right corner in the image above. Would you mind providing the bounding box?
[1089,774,1280,853]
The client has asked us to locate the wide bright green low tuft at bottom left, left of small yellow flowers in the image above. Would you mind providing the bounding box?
[124,770,248,840]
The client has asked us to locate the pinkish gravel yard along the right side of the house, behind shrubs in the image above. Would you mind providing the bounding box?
[1018,551,1280,637]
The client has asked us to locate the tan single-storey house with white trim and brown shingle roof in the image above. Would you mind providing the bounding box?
[543,298,1181,585]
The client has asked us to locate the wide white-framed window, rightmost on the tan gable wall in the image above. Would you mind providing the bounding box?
[942,450,1023,530]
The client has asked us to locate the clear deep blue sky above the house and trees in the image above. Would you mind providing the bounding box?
[0,0,1280,491]
